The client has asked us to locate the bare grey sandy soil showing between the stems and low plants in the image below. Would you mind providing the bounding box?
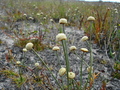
[0,0,120,90]
